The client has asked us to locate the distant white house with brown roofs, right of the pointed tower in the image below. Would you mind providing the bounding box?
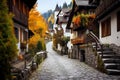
[56,8,71,51]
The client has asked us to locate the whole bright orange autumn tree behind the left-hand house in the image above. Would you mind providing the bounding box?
[29,5,48,53]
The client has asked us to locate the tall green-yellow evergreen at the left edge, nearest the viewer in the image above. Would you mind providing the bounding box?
[0,0,17,80]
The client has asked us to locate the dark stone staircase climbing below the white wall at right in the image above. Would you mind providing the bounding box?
[93,45,120,75]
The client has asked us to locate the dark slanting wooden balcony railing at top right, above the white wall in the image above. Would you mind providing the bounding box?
[95,0,117,16]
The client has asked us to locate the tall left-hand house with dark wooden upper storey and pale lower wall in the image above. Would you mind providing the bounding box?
[7,0,37,55]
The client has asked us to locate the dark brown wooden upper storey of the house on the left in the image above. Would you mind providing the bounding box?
[8,0,29,27]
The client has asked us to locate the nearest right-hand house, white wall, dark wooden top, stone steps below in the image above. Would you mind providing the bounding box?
[95,0,120,75]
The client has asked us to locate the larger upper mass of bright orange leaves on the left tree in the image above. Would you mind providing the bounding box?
[29,6,48,36]
